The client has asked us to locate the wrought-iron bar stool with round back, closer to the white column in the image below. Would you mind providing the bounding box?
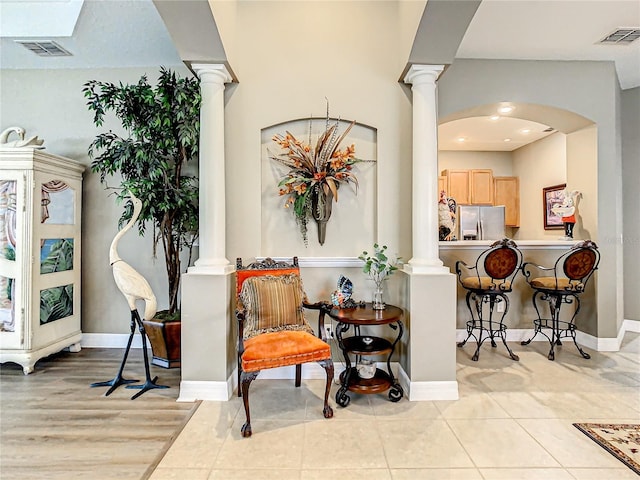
[456,238,522,361]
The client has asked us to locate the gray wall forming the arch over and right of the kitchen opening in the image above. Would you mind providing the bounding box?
[438,60,623,338]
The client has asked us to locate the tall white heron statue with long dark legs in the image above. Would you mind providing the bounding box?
[91,192,169,400]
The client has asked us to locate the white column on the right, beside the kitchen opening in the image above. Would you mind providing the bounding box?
[404,65,449,274]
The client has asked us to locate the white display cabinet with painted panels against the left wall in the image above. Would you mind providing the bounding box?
[0,147,84,375]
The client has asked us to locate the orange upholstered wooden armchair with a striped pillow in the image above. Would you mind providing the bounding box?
[236,257,333,437]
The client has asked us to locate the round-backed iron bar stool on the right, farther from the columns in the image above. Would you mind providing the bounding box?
[521,240,600,360]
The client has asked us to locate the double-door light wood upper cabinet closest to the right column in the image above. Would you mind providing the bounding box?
[442,169,494,205]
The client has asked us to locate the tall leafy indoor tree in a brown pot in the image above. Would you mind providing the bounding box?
[82,67,201,367]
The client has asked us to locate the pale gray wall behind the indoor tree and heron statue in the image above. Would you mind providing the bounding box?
[0,65,197,333]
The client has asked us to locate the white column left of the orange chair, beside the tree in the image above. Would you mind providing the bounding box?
[189,63,233,274]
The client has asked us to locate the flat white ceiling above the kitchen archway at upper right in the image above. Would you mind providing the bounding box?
[456,0,640,89]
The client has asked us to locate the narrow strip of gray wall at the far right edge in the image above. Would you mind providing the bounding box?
[621,87,640,320]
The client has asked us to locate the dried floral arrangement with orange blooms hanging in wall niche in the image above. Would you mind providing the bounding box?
[268,107,369,245]
